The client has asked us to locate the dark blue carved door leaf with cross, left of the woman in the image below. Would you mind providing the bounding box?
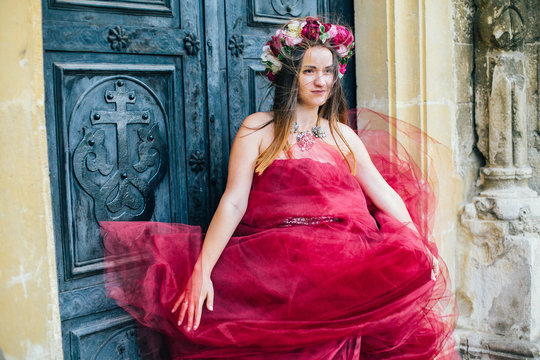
[43,0,210,359]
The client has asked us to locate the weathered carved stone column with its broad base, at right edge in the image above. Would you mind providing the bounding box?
[457,0,540,359]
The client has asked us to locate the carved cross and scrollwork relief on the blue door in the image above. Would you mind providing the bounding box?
[73,79,168,221]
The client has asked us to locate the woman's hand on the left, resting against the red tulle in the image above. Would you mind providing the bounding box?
[171,261,214,331]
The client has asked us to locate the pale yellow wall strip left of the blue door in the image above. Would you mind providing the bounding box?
[0,0,62,360]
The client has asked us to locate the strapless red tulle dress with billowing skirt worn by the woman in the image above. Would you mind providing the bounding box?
[101,112,459,360]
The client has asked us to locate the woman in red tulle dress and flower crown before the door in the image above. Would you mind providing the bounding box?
[103,18,458,359]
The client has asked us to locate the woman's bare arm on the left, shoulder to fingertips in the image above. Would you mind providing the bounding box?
[172,113,268,331]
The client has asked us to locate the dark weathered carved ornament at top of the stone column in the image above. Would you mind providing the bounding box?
[476,0,527,50]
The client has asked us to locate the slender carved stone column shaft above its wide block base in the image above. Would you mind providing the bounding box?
[476,0,536,201]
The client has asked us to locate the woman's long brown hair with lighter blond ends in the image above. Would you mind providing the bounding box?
[255,19,356,175]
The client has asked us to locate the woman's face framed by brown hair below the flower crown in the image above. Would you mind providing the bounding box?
[298,46,334,106]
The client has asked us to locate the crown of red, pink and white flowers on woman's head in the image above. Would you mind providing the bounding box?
[261,17,354,81]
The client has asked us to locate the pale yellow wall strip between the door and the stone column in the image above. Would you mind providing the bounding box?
[355,0,464,279]
